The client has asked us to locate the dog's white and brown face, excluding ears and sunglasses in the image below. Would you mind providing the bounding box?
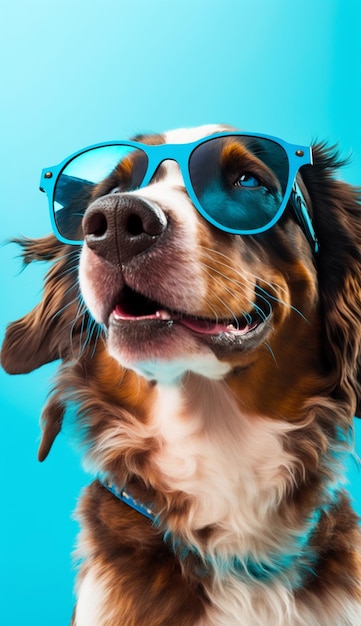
[80,127,317,394]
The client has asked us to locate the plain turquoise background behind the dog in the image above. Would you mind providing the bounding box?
[0,0,361,626]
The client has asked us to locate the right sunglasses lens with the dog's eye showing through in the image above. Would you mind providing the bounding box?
[189,135,289,233]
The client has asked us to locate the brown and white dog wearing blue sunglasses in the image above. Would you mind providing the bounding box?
[1,126,361,626]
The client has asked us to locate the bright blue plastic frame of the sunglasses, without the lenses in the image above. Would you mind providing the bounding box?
[40,132,318,252]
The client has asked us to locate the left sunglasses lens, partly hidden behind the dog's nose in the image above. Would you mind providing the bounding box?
[53,145,148,241]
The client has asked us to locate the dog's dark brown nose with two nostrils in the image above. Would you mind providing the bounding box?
[83,194,167,265]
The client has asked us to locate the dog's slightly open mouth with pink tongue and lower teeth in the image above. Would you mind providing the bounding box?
[110,287,271,336]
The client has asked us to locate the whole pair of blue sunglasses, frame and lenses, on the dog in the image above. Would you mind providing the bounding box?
[40,132,318,252]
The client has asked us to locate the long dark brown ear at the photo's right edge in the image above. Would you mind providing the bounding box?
[301,144,361,417]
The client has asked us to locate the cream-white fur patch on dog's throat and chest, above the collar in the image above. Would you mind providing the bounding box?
[153,379,295,532]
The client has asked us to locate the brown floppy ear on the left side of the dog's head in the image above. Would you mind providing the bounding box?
[1,235,92,374]
